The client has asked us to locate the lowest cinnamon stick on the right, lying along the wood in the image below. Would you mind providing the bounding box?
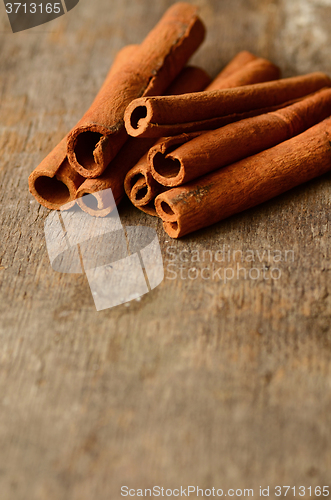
[155,118,331,238]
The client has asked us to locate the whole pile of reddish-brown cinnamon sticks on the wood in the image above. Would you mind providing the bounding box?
[29,3,331,238]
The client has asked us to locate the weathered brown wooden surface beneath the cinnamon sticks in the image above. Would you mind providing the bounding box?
[0,0,331,500]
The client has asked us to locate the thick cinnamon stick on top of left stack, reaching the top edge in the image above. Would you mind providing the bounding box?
[68,2,205,178]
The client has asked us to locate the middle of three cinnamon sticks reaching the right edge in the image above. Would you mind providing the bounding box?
[148,89,331,187]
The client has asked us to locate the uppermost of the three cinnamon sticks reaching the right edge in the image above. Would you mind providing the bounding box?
[124,72,331,137]
